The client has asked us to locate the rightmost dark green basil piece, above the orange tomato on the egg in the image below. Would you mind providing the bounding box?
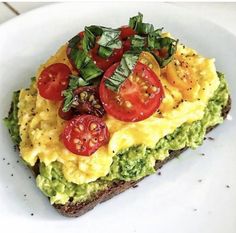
[151,37,178,68]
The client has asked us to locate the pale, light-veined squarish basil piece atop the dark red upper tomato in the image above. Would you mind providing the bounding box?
[97,27,122,49]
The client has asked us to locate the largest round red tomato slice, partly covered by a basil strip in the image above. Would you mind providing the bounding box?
[99,62,164,122]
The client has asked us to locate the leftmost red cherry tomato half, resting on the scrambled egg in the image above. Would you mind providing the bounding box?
[38,63,71,101]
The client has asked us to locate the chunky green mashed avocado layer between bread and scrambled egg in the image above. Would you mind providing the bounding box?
[5,73,229,204]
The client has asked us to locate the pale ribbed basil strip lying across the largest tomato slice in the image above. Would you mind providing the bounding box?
[105,52,140,92]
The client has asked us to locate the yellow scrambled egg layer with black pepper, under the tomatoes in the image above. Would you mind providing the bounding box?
[18,42,219,184]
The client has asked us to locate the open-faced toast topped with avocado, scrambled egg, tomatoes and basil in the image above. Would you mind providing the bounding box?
[5,14,230,216]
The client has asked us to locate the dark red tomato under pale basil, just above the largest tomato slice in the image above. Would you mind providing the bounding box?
[90,44,123,71]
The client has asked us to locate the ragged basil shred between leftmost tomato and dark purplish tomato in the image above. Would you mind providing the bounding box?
[62,75,89,112]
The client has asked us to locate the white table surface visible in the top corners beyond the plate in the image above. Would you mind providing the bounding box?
[0,2,236,35]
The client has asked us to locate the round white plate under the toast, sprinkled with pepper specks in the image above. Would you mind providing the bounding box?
[0,2,236,233]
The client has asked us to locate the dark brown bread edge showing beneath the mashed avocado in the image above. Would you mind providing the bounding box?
[53,97,231,217]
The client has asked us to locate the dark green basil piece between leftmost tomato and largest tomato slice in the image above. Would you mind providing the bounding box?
[80,56,103,81]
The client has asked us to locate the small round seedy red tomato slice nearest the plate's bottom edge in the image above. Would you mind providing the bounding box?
[61,115,109,156]
